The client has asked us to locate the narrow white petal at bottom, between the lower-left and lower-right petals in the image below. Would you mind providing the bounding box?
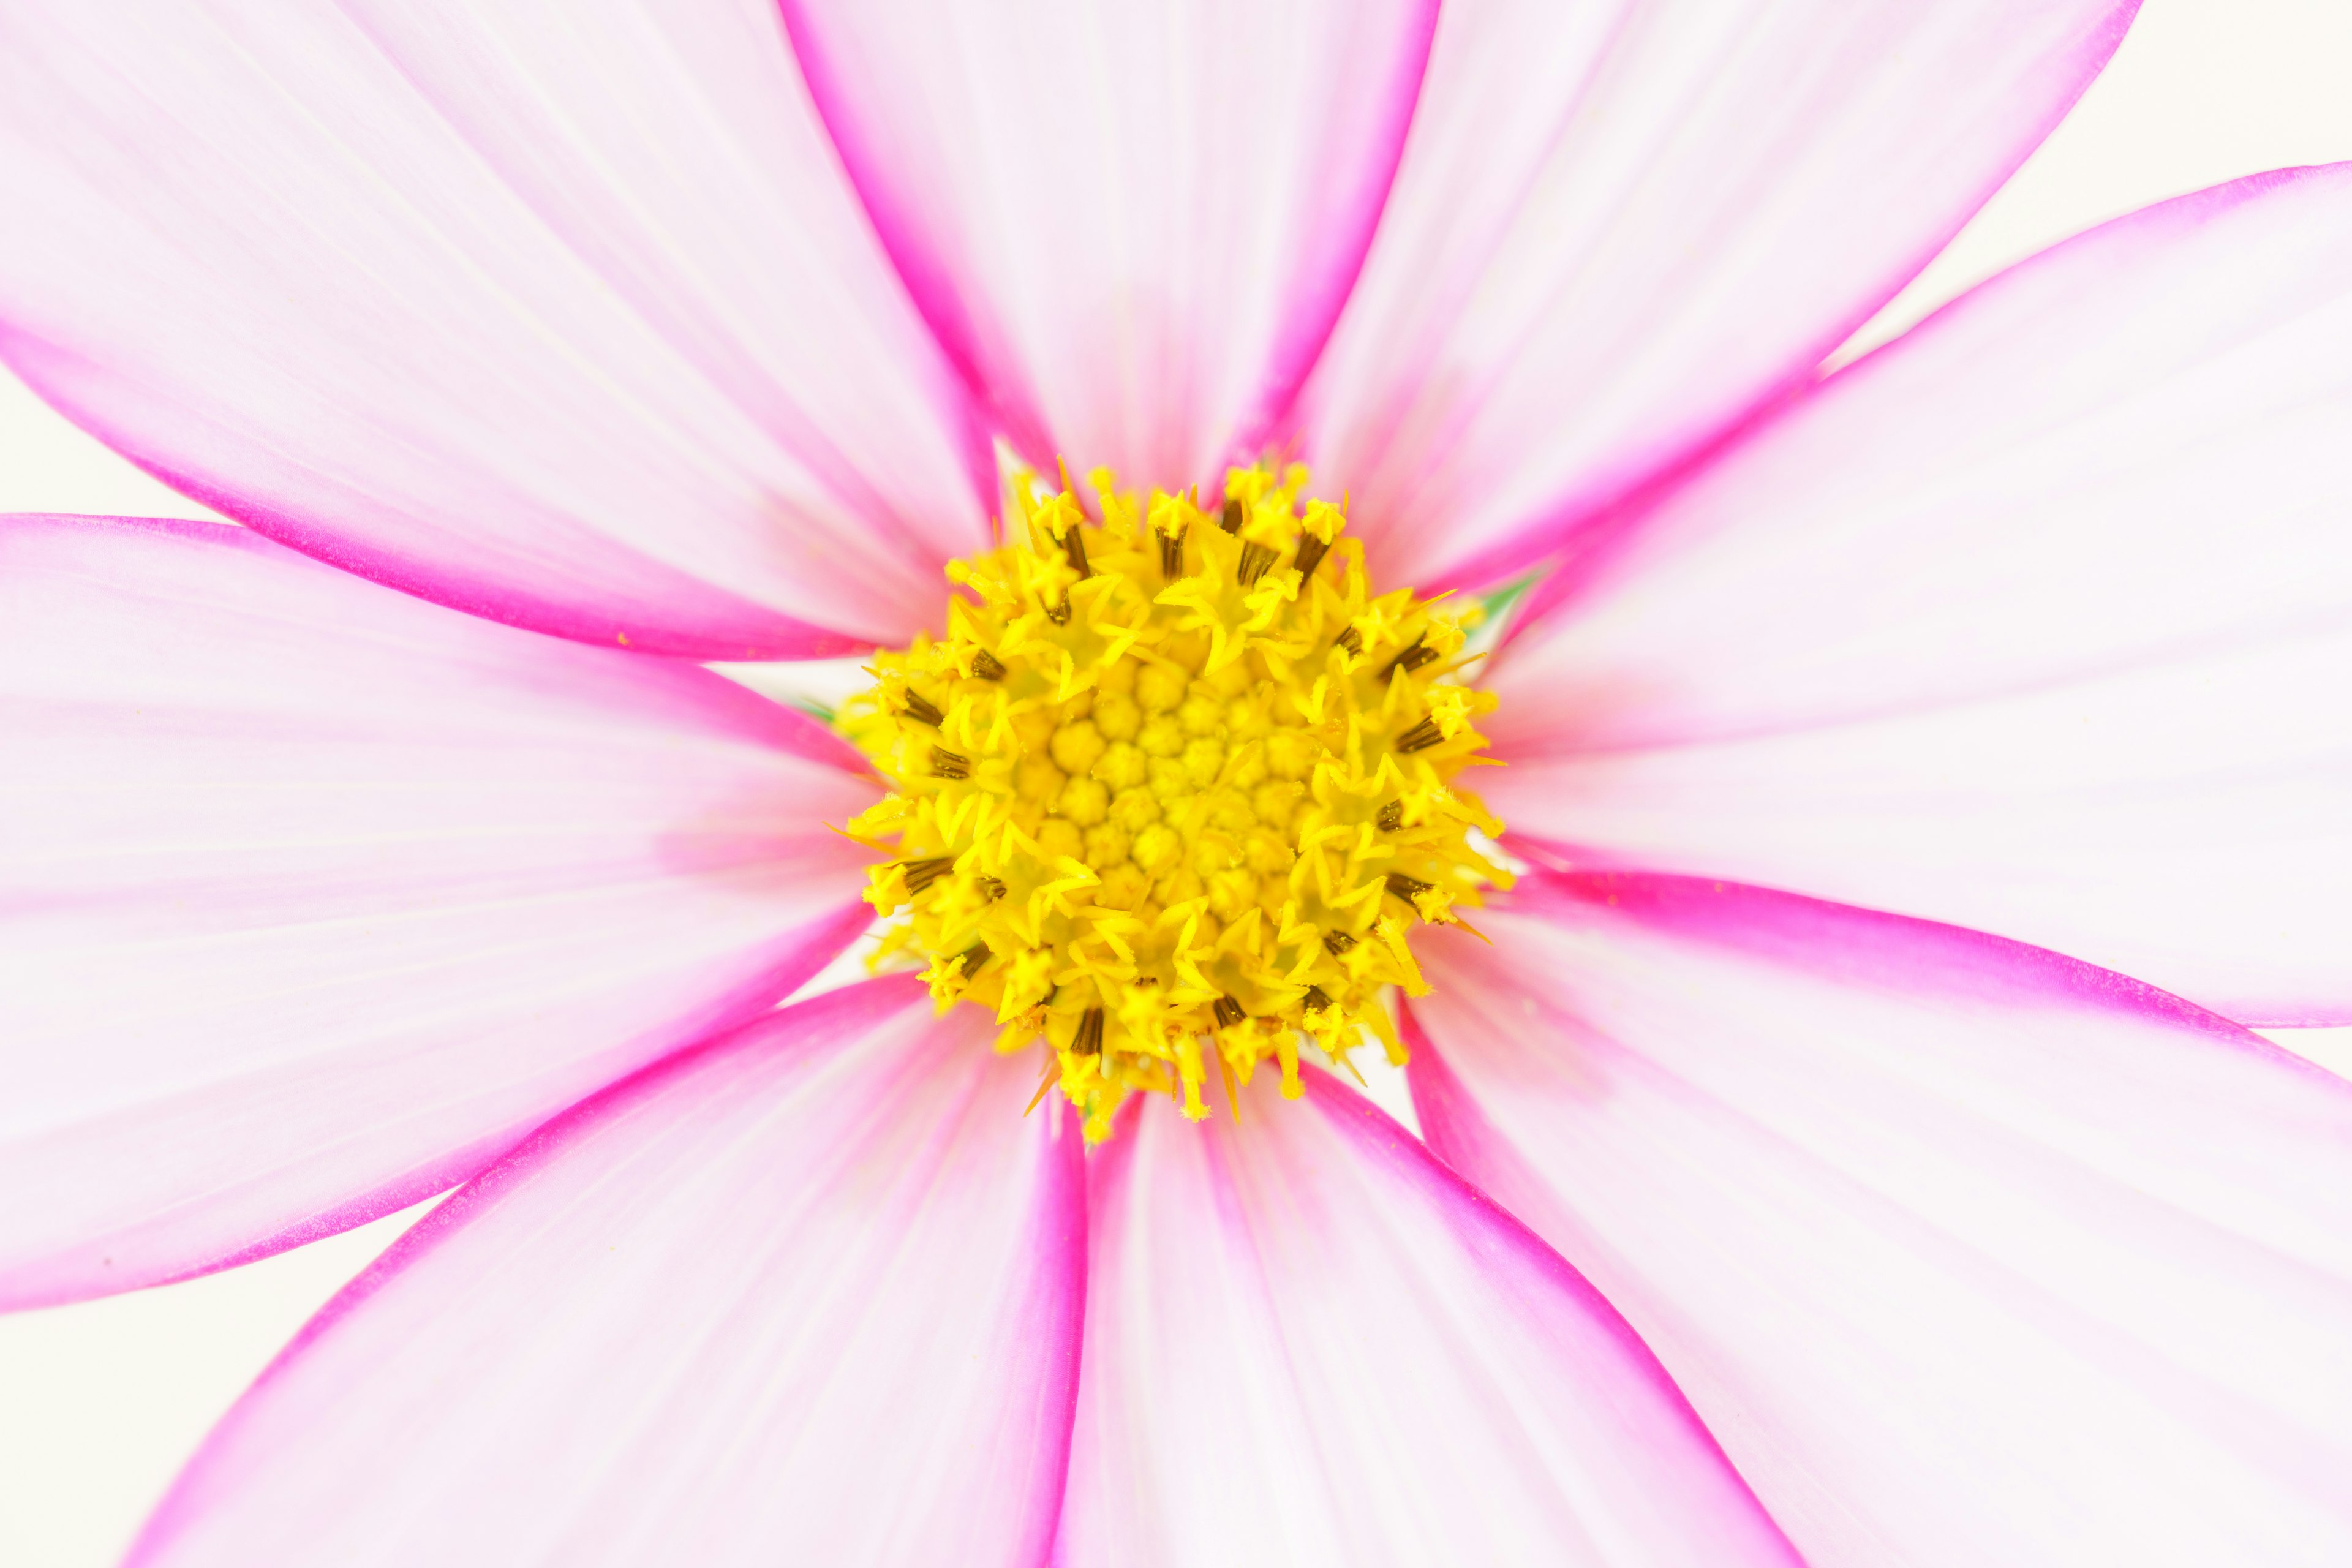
[1058,1074,1795,1568]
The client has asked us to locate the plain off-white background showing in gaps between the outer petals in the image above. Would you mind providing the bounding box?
[0,0,2352,1568]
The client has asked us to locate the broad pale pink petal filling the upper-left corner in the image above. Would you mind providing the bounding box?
[0,0,995,658]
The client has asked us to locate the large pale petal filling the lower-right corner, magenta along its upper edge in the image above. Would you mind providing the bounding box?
[1414,875,2352,1568]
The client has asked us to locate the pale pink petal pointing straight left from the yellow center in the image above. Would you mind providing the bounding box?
[0,517,875,1307]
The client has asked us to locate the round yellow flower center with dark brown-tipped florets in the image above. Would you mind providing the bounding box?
[842,466,1507,1140]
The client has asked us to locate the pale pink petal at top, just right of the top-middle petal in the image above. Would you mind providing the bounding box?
[1301,0,2138,588]
